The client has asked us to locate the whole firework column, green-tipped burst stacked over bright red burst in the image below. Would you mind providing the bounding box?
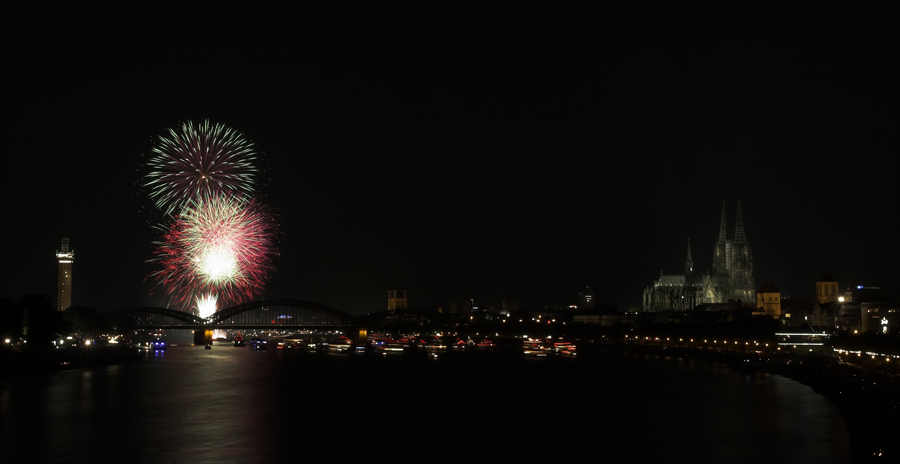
[140,120,278,317]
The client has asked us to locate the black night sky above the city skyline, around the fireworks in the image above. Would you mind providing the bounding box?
[0,2,900,314]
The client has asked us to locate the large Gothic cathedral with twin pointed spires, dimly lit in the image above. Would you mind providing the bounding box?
[643,201,756,311]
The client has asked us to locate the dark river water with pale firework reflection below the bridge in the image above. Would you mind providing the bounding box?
[0,345,850,464]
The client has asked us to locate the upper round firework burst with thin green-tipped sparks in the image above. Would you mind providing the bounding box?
[141,120,259,214]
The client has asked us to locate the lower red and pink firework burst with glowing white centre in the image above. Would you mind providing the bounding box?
[152,195,278,308]
